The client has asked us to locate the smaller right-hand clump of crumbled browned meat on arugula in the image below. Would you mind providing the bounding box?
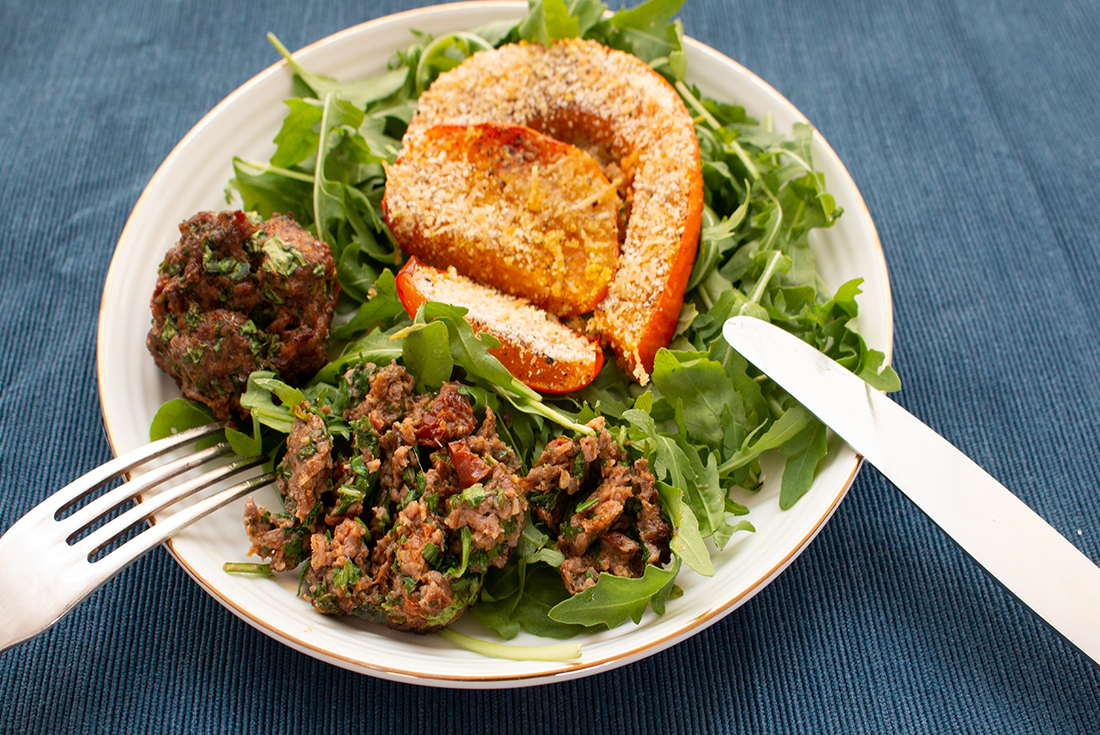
[526,417,672,594]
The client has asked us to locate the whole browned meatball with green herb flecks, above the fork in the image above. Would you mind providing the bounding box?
[145,211,340,421]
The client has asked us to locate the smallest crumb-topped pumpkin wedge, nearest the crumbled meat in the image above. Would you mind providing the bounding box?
[397,257,604,393]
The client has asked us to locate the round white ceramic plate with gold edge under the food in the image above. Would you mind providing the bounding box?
[98,1,893,688]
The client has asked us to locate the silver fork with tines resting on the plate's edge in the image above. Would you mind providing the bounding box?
[0,424,275,652]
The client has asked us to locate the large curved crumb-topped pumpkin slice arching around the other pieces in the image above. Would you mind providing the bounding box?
[404,39,703,383]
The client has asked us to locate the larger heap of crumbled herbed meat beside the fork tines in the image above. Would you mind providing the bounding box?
[245,364,527,633]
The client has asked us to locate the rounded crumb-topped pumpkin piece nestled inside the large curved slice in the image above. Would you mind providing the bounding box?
[382,122,619,316]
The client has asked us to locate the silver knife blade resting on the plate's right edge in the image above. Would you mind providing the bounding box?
[723,317,1100,665]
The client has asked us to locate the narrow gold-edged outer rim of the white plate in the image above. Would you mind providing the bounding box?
[96,0,894,688]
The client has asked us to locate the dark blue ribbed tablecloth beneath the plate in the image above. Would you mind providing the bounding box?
[0,0,1100,734]
